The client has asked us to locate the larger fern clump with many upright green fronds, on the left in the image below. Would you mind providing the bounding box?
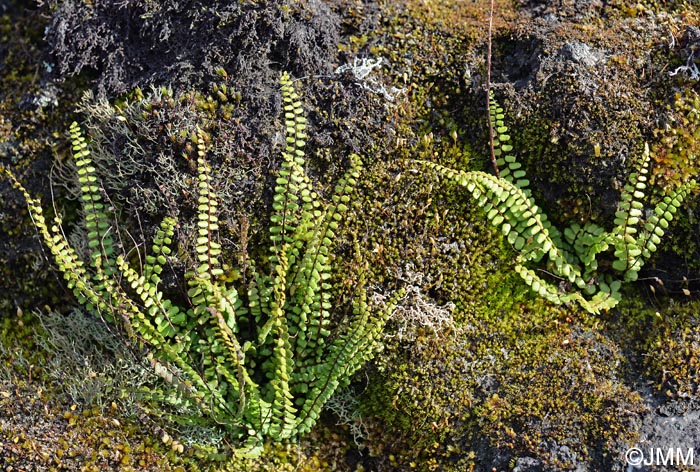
[6,73,400,456]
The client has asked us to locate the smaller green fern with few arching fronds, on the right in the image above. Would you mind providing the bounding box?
[421,95,695,313]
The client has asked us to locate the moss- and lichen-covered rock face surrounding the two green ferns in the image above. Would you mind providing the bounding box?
[0,0,700,471]
